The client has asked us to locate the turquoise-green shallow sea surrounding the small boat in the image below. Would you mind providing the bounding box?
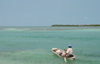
[0,26,100,64]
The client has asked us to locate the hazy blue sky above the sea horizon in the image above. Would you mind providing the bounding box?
[0,0,100,26]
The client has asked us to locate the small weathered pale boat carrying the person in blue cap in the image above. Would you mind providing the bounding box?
[52,48,75,60]
